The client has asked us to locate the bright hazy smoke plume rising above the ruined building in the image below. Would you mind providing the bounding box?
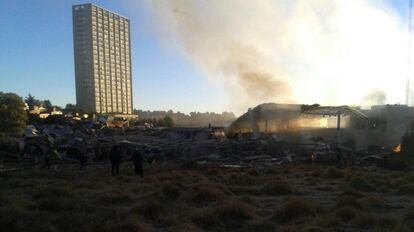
[141,0,408,112]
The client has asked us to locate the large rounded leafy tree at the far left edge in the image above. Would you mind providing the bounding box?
[0,92,27,136]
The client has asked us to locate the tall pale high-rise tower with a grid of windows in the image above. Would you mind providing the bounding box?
[72,4,132,114]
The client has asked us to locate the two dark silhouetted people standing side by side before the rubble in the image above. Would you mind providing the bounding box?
[109,145,144,178]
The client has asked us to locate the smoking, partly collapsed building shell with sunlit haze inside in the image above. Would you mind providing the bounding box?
[227,103,414,152]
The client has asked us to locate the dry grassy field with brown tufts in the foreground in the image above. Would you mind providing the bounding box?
[0,162,414,232]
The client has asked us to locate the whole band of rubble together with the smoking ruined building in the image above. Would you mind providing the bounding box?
[0,103,414,170]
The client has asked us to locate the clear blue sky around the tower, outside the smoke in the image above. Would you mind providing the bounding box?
[0,0,408,112]
